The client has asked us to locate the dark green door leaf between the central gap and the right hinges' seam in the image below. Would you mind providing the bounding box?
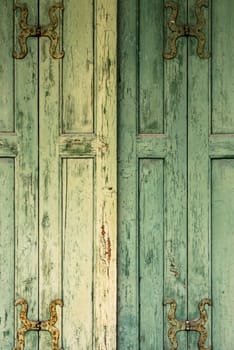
[118,1,187,349]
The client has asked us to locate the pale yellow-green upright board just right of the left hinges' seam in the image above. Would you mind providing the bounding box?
[38,0,62,350]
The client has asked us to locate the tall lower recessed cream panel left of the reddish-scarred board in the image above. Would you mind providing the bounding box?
[62,158,95,350]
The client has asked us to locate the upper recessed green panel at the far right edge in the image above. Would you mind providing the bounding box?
[212,0,234,134]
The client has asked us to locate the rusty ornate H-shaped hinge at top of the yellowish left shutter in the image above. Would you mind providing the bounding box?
[13,3,64,58]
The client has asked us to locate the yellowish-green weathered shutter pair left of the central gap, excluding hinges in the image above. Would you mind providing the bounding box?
[0,0,116,350]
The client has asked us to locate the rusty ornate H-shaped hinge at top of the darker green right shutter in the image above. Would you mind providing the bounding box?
[163,0,210,59]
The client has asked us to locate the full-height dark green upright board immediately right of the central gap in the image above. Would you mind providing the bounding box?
[118,0,139,350]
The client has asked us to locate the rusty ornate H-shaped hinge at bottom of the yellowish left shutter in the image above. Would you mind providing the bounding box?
[14,299,63,350]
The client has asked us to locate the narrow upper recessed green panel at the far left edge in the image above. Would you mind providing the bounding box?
[0,0,15,132]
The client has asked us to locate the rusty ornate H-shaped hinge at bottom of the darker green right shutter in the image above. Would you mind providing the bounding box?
[163,299,212,350]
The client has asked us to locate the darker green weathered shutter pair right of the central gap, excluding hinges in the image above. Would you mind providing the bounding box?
[118,0,234,350]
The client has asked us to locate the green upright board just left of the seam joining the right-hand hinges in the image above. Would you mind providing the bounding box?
[164,1,187,350]
